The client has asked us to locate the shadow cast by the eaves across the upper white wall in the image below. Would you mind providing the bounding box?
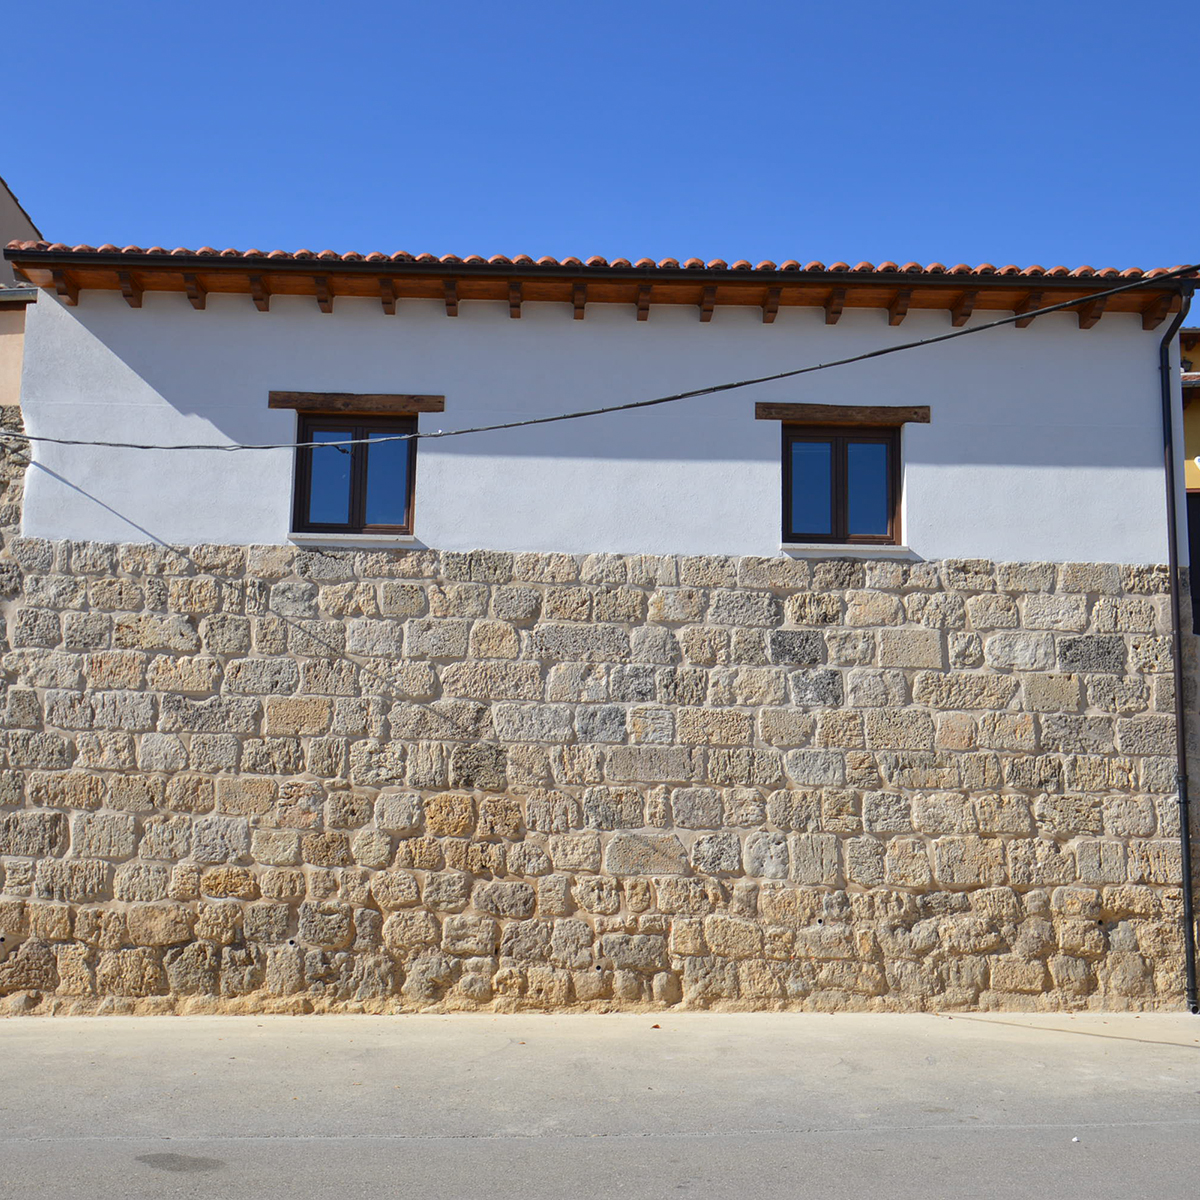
[28,293,1157,467]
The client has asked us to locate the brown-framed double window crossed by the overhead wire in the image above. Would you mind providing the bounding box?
[293,414,416,533]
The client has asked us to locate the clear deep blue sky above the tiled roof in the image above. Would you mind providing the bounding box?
[11,0,1200,268]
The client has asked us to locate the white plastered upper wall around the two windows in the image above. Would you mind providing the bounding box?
[22,292,1166,563]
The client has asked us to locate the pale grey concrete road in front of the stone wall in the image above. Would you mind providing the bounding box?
[0,1014,1200,1200]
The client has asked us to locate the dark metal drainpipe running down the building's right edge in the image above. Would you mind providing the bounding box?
[1158,289,1200,1013]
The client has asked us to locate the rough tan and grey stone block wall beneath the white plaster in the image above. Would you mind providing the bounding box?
[0,422,1182,1013]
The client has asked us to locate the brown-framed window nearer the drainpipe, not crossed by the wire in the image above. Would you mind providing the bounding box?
[784,425,900,545]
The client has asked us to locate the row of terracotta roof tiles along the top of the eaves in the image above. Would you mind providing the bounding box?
[7,240,1190,280]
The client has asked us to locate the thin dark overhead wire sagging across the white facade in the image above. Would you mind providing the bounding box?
[0,263,1200,452]
